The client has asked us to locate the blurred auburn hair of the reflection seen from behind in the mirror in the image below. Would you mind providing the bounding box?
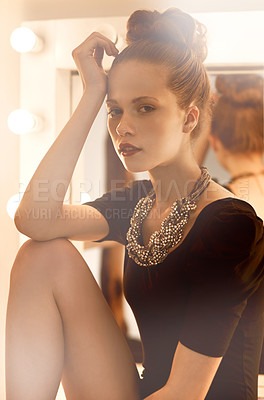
[212,74,264,153]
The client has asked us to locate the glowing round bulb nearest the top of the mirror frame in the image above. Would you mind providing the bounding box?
[10,27,43,53]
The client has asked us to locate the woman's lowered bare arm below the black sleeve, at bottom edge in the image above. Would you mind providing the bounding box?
[145,342,222,400]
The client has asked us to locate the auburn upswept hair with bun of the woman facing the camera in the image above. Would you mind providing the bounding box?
[110,8,211,137]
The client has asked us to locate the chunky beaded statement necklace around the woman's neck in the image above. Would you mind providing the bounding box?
[126,167,211,267]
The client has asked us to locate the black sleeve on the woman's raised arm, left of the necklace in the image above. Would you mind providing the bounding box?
[84,180,152,244]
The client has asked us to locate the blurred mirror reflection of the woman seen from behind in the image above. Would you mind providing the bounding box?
[210,74,264,219]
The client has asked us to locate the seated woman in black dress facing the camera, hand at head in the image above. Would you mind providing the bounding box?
[7,9,264,400]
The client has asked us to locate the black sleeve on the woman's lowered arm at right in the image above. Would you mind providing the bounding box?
[180,200,264,357]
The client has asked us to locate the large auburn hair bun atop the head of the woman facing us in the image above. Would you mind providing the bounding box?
[126,8,207,61]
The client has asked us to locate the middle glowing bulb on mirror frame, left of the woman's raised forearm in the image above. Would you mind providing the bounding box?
[7,109,42,135]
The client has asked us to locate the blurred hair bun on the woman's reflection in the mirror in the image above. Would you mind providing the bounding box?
[215,74,263,106]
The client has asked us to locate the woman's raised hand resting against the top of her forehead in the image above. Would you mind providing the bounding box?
[72,32,118,93]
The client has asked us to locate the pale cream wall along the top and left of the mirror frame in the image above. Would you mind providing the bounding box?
[0,0,264,400]
